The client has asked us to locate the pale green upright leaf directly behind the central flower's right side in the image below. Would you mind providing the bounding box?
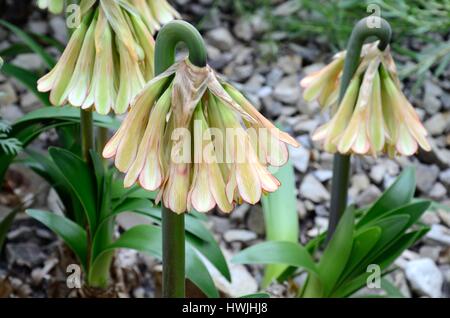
[261,161,299,288]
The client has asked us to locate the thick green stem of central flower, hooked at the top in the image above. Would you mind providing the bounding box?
[155,21,206,298]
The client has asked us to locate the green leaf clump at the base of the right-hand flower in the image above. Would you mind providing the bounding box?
[233,168,431,297]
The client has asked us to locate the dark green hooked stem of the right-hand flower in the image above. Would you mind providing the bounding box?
[327,17,392,240]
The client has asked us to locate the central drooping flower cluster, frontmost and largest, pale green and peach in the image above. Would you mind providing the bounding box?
[103,60,298,213]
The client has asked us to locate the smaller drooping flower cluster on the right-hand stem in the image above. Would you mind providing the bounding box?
[301,42,431,156]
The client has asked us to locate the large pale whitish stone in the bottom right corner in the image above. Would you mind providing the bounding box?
[405,258,444,298]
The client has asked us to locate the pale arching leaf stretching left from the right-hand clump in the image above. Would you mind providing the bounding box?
[232,241,318,274]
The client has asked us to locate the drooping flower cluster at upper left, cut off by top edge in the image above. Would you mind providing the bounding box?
[38,0,179,114]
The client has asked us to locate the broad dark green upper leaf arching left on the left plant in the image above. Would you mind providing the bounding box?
[49,148,98,233]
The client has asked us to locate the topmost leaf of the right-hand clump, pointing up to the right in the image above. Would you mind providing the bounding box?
[358,167,416,227]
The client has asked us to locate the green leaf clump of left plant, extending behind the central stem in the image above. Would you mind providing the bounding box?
[23,148,231,297]
